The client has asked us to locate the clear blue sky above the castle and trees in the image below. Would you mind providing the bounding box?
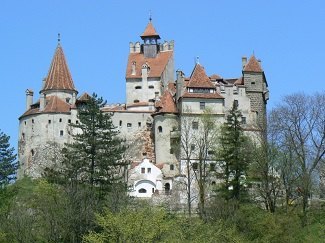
[0,0,325,150]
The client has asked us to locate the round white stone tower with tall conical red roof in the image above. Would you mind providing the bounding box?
[18,39,78,178]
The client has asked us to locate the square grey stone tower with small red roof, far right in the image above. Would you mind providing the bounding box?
[242,55,269,131]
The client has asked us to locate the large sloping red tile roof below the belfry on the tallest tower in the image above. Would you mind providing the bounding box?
[126,51,173,78]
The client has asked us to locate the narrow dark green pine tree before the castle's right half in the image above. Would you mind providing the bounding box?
[218,102,249,200]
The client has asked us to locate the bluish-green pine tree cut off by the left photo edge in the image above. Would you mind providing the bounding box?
[0,131,18,188]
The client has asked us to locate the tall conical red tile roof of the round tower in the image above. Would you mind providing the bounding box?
[43,44,76,91]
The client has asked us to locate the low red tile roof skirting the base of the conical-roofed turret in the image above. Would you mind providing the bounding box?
[21,96,72,117]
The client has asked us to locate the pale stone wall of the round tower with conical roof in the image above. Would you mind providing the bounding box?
[18,110,77,177]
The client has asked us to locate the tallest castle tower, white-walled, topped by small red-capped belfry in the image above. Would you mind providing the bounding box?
[126,19,174,111]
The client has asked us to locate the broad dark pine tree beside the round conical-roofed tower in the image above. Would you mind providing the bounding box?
[55,94,126,194]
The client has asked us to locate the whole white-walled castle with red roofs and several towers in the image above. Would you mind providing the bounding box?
[18,19,269,197]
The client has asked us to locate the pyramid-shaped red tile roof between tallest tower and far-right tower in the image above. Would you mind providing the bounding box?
[187,64,215,88]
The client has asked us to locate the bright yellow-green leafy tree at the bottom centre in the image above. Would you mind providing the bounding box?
[84,206,179,242]
